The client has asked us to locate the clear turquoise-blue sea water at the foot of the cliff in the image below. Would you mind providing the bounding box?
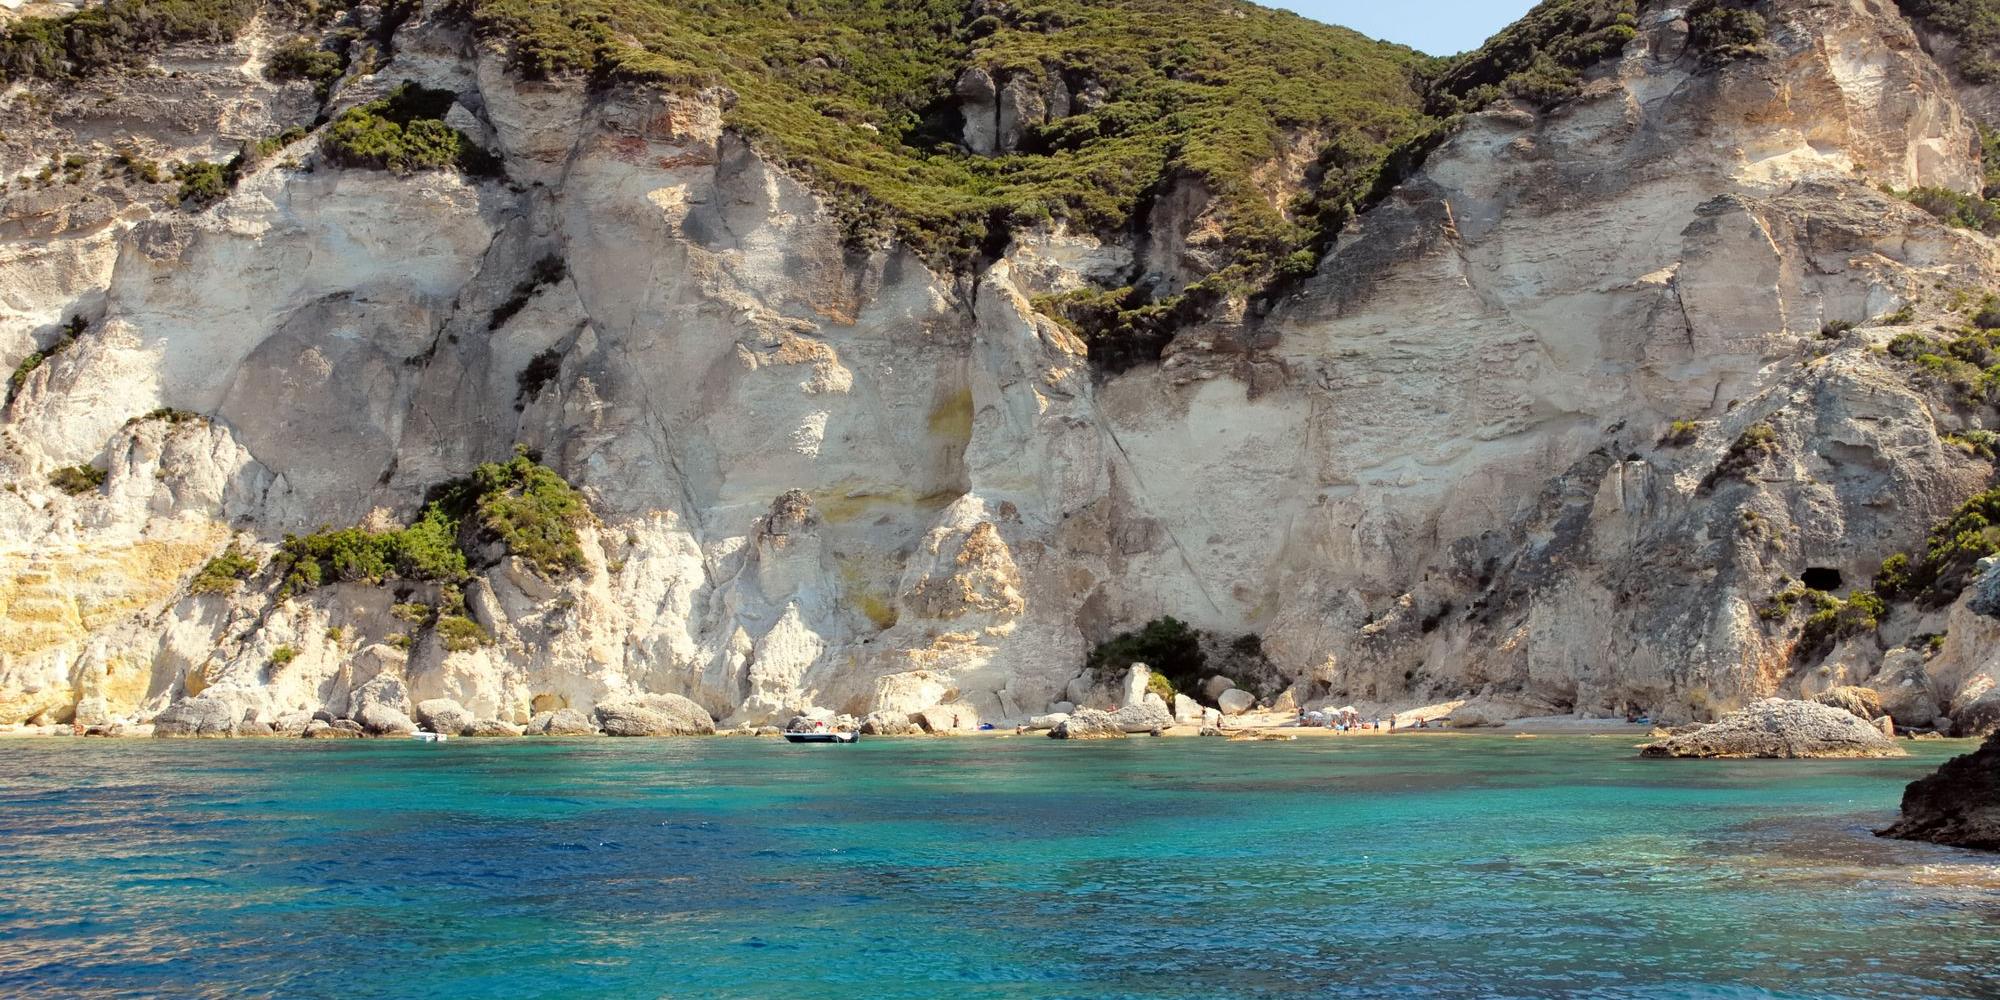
[0,736,2000,998]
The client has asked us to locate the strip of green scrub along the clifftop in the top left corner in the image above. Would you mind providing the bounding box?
[0,0,260,82]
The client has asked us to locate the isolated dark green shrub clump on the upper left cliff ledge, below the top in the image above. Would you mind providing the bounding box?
[320,80,500,174]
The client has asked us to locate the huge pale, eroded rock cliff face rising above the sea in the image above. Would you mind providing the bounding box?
[0,0,2000,732]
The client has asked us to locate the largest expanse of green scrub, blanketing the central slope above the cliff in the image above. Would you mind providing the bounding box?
[472,0,1432,364]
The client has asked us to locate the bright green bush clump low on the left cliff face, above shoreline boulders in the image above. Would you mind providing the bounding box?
[272,454,590,596]
